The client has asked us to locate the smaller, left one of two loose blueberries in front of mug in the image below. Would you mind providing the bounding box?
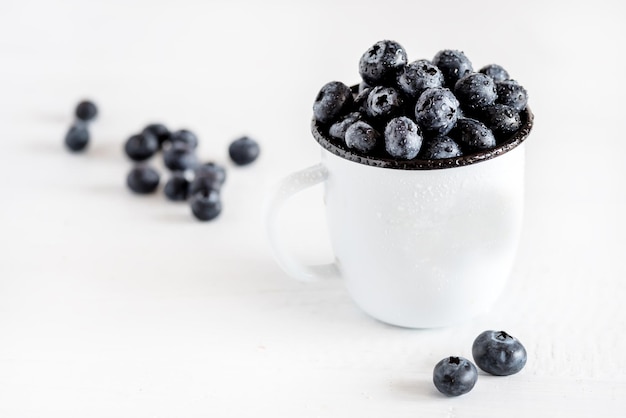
[433,357,478,396]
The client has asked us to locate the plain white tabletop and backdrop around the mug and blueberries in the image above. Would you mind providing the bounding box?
[0,0,626,418]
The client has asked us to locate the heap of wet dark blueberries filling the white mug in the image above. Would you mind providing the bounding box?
[313,40,528,160]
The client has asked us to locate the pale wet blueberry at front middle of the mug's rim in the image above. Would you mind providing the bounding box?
[385,116,422,160]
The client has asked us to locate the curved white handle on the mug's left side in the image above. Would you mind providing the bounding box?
[265,163,339,282]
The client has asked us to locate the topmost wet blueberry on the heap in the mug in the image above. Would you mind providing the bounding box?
[359,40,408,86]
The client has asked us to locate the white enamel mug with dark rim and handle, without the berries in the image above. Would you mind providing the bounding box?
[266,110,533,328]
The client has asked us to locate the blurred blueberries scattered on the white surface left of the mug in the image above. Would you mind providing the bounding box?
[65,101,260,221]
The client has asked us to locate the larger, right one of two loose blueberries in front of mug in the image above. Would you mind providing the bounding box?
[472,331,527,376]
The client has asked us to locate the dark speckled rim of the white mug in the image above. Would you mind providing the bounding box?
[311,107,534,170]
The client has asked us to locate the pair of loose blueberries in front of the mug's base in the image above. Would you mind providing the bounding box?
[433,331,527,396]
